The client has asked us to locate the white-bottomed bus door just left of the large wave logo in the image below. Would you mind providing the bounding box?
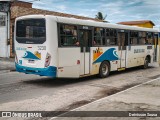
[79,29,92,75]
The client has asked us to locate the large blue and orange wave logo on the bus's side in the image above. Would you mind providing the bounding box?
[93,48,119,64]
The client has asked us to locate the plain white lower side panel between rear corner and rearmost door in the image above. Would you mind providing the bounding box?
[57,47,80,78]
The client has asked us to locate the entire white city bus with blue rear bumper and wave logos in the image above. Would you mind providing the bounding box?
[14,15,159,78]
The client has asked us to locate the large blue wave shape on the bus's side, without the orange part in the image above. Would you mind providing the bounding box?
[93,48,119,64]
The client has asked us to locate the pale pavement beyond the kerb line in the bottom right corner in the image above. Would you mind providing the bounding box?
[53,77,160,120]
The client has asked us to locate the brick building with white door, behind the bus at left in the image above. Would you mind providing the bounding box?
[0,0,100,57]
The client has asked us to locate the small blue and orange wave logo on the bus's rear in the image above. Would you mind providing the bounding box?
[23,51,41,60]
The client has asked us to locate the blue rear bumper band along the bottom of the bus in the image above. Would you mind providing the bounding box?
[15,63,57,77]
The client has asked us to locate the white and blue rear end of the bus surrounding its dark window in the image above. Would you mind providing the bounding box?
[15,16,58,77]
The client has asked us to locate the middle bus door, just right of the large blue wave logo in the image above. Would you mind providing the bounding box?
[118,30,128,69]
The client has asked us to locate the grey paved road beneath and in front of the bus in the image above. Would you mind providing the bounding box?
[0,64,160,111]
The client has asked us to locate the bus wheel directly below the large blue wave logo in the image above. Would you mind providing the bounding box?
[99,61,110,78]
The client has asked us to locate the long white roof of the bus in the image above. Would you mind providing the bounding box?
[16,15,158,32]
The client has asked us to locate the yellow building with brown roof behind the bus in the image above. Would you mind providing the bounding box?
[117,20,155,28]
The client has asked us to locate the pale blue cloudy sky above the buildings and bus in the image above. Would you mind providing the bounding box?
[24,0,160,26]
